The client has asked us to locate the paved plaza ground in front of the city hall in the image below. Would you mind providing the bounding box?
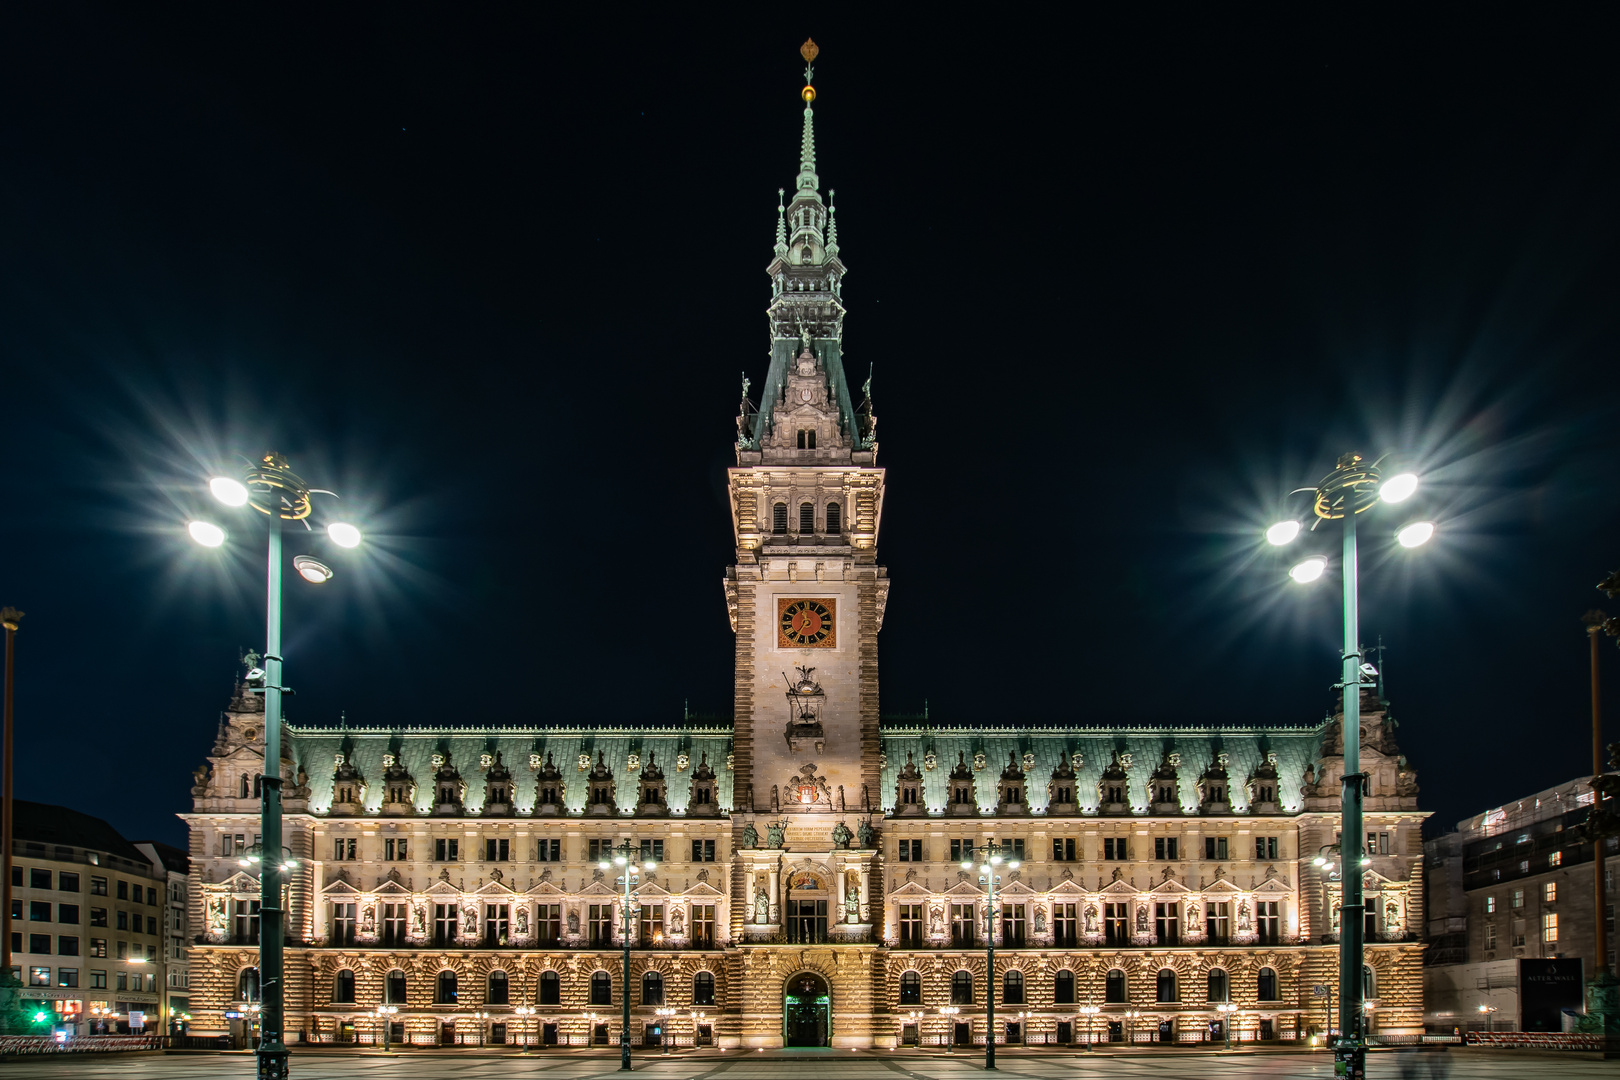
[0,1049,1617,1080]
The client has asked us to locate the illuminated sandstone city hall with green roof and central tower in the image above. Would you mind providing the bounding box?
[183,47,1424,1048]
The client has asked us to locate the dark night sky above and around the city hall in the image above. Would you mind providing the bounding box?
[0,3,1620,844]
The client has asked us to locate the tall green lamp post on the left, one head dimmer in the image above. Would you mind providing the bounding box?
[186,452,360,1080]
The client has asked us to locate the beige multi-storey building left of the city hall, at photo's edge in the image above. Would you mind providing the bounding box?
[11,800,167,1035]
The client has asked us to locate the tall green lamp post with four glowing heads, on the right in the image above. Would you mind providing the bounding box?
[1265,453,1434,1080]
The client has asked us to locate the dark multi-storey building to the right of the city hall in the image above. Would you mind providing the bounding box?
[1424,777,1620,1031]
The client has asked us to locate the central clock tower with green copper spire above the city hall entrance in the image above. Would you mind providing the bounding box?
[726,57,889,832]
